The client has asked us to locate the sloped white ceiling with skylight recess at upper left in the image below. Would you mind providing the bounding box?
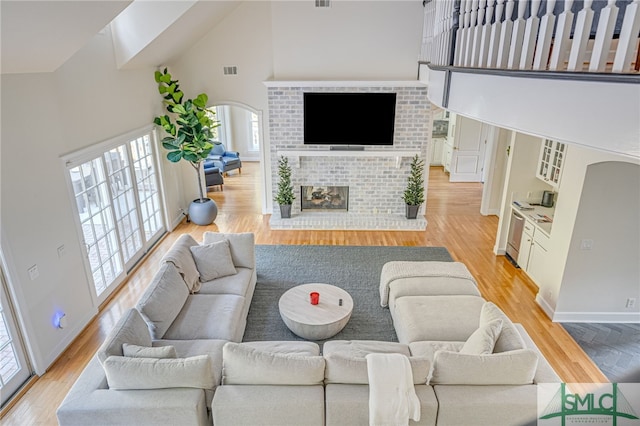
[0,0,241,74]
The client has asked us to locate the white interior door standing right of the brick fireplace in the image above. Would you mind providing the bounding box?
[449,116,488,182]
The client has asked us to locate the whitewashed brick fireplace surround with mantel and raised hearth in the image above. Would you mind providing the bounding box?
[265,81,431,230]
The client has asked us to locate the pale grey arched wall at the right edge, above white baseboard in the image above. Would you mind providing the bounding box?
[555,161,640,321]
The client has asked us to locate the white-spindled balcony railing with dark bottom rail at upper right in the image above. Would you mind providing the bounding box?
[421,0,640,74]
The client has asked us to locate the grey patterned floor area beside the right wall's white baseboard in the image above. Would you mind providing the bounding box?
[562,323,640,383]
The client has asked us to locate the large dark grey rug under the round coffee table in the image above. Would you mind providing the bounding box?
[243,245,452,343]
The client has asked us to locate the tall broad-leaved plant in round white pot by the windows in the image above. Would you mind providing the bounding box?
[153,68,220,225]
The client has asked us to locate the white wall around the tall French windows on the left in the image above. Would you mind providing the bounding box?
[1,32,161,373]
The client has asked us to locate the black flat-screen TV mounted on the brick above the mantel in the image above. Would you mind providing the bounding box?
[304,93,396,145]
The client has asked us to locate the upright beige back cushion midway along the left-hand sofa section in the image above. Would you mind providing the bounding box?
[136,263,189,339]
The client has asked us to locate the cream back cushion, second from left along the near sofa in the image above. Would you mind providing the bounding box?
[222,342,325,385]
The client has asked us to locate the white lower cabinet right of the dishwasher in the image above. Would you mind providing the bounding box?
[518,215,549,285]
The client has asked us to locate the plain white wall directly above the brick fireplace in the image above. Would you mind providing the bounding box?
[272,1,424,80]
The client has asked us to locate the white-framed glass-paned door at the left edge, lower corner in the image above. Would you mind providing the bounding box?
[0,267,31,407]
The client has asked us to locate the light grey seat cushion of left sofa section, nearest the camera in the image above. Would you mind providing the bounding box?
[163,294,246,340]
